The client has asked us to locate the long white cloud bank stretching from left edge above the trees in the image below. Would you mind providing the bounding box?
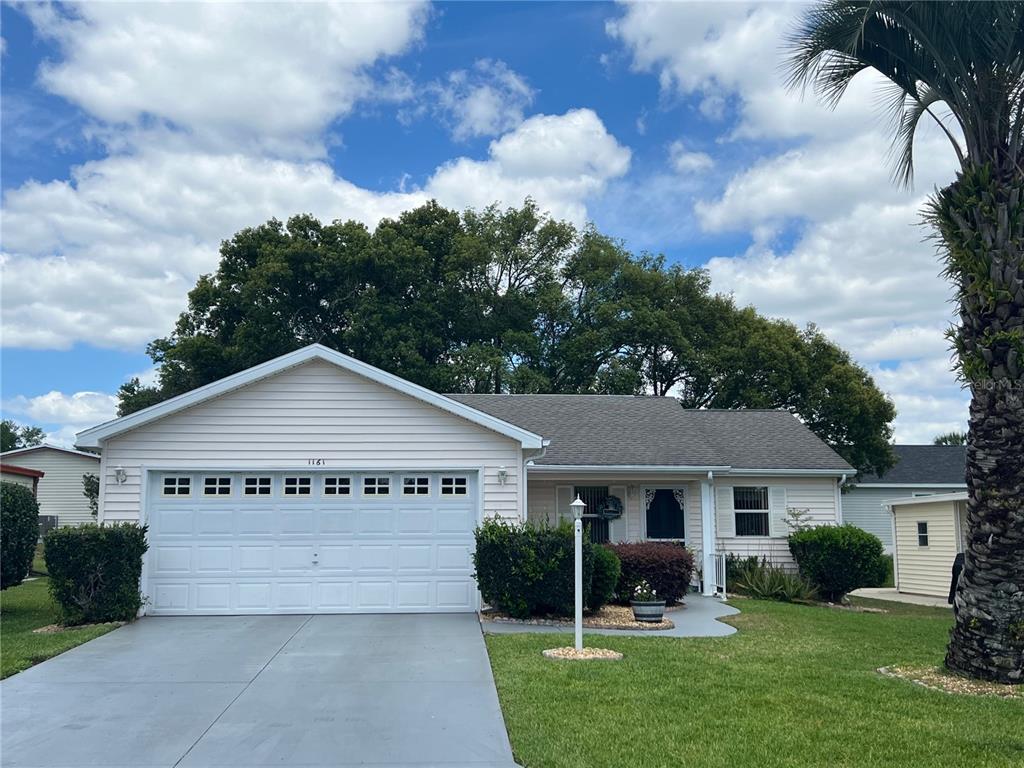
[0,110,630,348]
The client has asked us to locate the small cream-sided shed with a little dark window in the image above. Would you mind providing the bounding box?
[889,492,967,597]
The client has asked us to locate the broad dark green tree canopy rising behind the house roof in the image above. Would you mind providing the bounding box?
[120,200,895,472]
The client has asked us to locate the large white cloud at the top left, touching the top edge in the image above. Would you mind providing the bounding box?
[25,2,427,156]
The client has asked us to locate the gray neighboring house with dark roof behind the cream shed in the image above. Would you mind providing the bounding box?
[843,445,967,553]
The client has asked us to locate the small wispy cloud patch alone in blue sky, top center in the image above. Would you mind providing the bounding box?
[425,58,534,141]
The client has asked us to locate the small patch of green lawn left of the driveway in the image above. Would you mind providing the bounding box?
[0,579,115,678]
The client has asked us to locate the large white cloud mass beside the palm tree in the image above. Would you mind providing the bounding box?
[608,3,967,441]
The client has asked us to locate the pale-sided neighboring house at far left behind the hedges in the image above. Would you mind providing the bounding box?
[0,443,99,525]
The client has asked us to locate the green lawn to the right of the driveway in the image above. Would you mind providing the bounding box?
[487,600,1024,768]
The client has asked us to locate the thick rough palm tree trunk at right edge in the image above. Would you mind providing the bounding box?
[931,166,1024,683]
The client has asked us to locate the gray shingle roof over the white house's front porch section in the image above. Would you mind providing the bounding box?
[447,394,853,473]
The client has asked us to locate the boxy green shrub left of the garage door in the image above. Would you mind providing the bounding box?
[44,522,148,625]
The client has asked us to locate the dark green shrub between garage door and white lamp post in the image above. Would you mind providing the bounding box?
[473,519,594,618]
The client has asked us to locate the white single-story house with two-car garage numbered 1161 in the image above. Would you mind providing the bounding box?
[78,345,853,613]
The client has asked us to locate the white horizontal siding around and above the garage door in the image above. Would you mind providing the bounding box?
[99,360,522,520]
